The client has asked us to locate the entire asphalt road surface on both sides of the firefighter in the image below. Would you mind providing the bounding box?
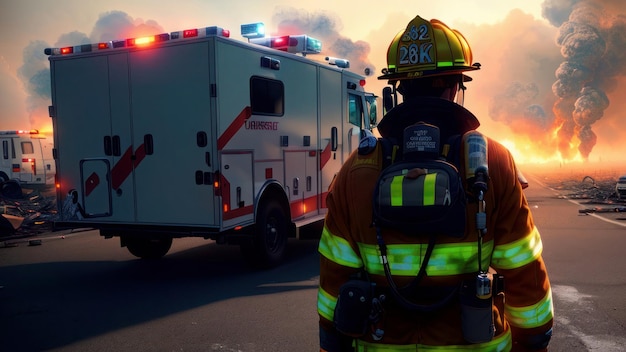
[0,178,626,352]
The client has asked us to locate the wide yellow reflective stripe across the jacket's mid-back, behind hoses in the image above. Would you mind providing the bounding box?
[359,241,493,276]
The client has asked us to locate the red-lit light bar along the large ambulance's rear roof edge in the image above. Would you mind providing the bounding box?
[44,26,230,55]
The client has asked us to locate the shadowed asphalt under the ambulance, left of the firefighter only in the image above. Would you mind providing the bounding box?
[0,231,318,352]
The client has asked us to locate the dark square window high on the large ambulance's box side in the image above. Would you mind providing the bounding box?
[250,76,285,116]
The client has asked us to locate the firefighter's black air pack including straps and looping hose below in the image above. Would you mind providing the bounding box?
[366,123,487,312]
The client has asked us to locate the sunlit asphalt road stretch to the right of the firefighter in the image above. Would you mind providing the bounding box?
[526,178,626,352]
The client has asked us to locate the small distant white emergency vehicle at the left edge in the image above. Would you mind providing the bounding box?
[0,130,55,184]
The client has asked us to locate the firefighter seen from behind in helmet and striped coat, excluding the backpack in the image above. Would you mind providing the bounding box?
[317,16,553,352]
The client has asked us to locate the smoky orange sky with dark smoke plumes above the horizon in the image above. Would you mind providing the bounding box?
[0,0,626,162]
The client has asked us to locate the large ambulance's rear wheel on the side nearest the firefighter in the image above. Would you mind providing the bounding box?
[241,200,289,269]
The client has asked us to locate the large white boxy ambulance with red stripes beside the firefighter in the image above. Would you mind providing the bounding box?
[45,24,377,266]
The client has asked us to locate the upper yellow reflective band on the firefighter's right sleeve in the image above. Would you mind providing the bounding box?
[492,227,543,269]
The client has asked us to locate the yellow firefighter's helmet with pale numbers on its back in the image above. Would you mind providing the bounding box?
[378,16,480,80]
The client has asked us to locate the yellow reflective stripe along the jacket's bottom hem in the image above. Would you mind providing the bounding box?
[355,330,513,352]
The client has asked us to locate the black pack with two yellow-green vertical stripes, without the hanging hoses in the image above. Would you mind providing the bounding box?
[373,123,466,238]
